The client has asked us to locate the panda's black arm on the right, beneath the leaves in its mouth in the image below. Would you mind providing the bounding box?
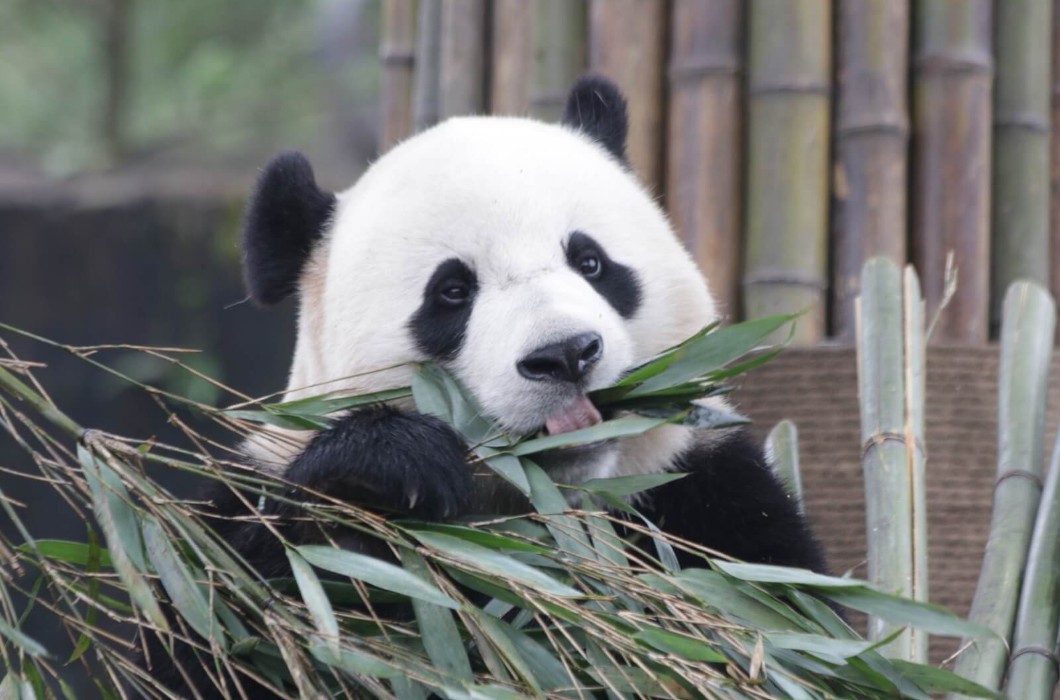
[640,430,825,573]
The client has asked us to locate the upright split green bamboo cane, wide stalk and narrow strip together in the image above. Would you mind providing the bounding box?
[855,258,928,660]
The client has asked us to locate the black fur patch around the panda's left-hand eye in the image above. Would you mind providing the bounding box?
[409,258,477,360]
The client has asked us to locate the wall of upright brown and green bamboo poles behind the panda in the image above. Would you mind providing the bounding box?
[381,0,1060,345]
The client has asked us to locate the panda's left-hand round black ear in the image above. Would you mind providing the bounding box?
[243,151,335,305]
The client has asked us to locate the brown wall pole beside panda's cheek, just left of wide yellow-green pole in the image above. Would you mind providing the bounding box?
[666,0,744,318]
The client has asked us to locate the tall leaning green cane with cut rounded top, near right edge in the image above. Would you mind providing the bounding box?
[950,282,1056,698]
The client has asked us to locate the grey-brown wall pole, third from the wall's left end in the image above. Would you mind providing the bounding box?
[436,0,488,119]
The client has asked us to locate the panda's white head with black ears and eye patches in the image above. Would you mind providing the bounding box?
[244,76,716,478]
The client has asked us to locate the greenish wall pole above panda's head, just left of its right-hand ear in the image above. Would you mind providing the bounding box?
[530,0,588,122]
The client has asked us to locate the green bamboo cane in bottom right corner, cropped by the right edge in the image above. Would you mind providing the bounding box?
[1005,436,1060,700]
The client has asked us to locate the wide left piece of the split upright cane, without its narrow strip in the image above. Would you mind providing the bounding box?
[855,258,918,659]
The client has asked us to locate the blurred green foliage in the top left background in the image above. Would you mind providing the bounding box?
[0,0,378,174]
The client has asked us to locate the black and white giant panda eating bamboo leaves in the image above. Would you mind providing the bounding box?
[138,76,825,684]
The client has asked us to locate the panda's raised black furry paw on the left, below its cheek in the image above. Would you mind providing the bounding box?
[286,407,472,520]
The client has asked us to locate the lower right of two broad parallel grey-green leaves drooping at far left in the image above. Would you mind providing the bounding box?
[143,515,218,648]
